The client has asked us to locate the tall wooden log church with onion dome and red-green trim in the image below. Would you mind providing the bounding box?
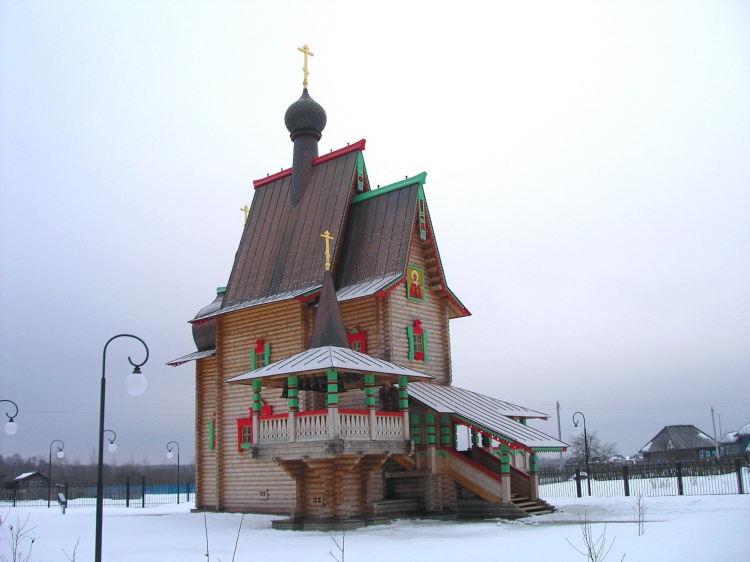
[169,47,566,529]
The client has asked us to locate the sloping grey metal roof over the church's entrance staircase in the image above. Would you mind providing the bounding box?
[408,382,567,451]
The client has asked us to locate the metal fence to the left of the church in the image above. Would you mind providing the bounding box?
[0,476,195,509]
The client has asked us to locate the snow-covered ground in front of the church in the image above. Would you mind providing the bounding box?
[0,495,750,562]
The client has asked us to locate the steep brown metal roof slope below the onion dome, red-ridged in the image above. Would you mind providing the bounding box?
[219,151,357,313]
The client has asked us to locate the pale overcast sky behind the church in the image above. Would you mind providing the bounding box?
[0,0,750,463]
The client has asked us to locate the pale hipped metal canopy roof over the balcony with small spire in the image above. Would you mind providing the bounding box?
[225,345,435,387]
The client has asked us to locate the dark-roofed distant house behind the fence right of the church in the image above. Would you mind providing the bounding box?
[639,425,716,462]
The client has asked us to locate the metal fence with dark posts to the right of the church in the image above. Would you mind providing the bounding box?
[539,457,750,498]
